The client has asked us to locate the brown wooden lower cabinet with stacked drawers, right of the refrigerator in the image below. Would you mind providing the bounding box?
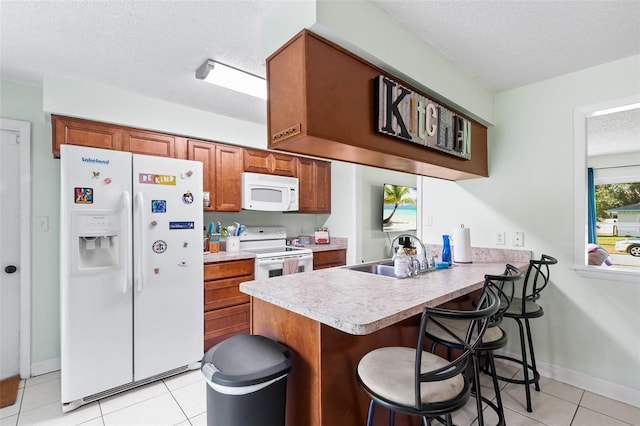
[204,259,254,352]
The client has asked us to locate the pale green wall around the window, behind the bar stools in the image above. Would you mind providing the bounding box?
[423,56,640,405]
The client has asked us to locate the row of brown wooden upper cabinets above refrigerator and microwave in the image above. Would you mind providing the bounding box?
[51,115,331,213]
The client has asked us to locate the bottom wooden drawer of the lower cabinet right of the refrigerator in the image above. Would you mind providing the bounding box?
[204,303,250,351]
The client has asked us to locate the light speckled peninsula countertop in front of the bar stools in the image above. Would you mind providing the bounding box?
[240,251,531,335]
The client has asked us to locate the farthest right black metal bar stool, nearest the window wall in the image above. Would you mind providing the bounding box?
[495,254,558,412]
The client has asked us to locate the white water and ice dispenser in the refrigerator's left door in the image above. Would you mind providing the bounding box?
[72,212,121,272]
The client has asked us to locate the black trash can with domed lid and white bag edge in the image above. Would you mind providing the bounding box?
[201,334,291,426]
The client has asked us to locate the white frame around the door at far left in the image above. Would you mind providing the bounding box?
[0,118,31,379]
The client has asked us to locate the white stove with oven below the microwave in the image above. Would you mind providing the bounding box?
[240,226,313,280]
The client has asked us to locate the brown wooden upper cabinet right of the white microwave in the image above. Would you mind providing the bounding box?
[298,157,331,213]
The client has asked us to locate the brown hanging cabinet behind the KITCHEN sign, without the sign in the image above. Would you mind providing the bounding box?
[267,30,489,180]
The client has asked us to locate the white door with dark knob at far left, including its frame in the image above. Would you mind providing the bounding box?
[0,119,30,380]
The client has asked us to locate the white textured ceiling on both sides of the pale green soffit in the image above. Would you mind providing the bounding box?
[0,0,640,156]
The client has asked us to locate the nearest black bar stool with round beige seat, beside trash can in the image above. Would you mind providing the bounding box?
[356,291,500,426]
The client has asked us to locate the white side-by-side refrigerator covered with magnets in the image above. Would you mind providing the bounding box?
[60,145,203,411]
